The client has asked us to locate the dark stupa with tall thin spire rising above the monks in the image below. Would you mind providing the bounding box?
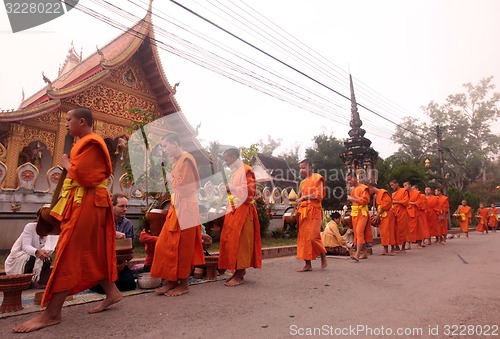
[340,75,378,183]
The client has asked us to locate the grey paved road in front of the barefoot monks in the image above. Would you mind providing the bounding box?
[0,232,500,339]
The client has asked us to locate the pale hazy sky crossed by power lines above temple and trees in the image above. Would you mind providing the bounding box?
[0,0,500,157]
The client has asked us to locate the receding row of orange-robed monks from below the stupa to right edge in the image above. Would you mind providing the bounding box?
[347,176,498,261]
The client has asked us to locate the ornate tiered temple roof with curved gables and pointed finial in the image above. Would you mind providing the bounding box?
[0,1,208,163]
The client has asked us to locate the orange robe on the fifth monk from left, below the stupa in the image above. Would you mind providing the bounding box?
[351,184,373,245]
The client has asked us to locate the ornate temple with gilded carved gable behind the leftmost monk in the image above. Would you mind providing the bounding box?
[0,2,211,249]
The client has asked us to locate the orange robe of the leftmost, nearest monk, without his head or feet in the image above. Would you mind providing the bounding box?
[42,133,118,307]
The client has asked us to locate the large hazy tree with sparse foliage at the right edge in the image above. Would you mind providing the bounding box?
[392,77,500,190]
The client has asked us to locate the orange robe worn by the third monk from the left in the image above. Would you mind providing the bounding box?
[219,164,262,272]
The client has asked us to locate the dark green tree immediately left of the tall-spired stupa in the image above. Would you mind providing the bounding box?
[306,133,346,209]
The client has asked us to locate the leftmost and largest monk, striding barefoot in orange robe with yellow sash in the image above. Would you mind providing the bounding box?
[13,107,122,332]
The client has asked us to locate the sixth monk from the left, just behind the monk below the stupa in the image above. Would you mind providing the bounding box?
[369,184,396,256]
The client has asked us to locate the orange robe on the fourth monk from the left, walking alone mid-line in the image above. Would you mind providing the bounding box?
[297,173,326,260]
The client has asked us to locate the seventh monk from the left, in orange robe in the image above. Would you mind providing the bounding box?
[389,179,410,253]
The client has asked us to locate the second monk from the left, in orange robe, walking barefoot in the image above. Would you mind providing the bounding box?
[150,133,205,297]
